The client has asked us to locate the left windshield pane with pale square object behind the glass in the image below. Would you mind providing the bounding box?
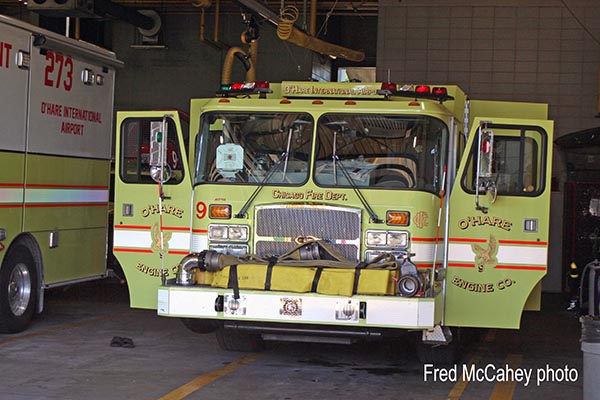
[195,112,314,185]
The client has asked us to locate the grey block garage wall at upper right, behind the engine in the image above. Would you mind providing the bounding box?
[377,0,600,291]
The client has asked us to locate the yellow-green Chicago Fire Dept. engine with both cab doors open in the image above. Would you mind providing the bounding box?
[114,81,553,358]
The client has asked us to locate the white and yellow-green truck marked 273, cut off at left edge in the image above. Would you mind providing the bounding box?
[0,15,122,332]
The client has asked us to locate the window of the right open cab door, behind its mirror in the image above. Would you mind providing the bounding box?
[463,125,547,196]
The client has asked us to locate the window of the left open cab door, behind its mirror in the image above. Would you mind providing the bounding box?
[120,118,184,185]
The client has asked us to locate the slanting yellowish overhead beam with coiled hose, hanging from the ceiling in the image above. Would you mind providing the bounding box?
[238,0,365,62]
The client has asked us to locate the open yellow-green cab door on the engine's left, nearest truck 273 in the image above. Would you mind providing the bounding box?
[113,111,192,309]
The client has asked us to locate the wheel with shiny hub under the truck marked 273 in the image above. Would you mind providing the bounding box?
[0,244,38,333]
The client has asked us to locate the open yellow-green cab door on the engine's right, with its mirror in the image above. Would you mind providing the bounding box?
[444,118,553,328]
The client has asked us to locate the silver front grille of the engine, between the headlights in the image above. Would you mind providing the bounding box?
[255,205,361,261]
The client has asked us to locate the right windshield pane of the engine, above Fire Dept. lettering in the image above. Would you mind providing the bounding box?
[314,114,448,193]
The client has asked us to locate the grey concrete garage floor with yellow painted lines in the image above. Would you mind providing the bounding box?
[0,280,583,400]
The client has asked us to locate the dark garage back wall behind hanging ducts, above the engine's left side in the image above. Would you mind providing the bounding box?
[112,14,313,110]
